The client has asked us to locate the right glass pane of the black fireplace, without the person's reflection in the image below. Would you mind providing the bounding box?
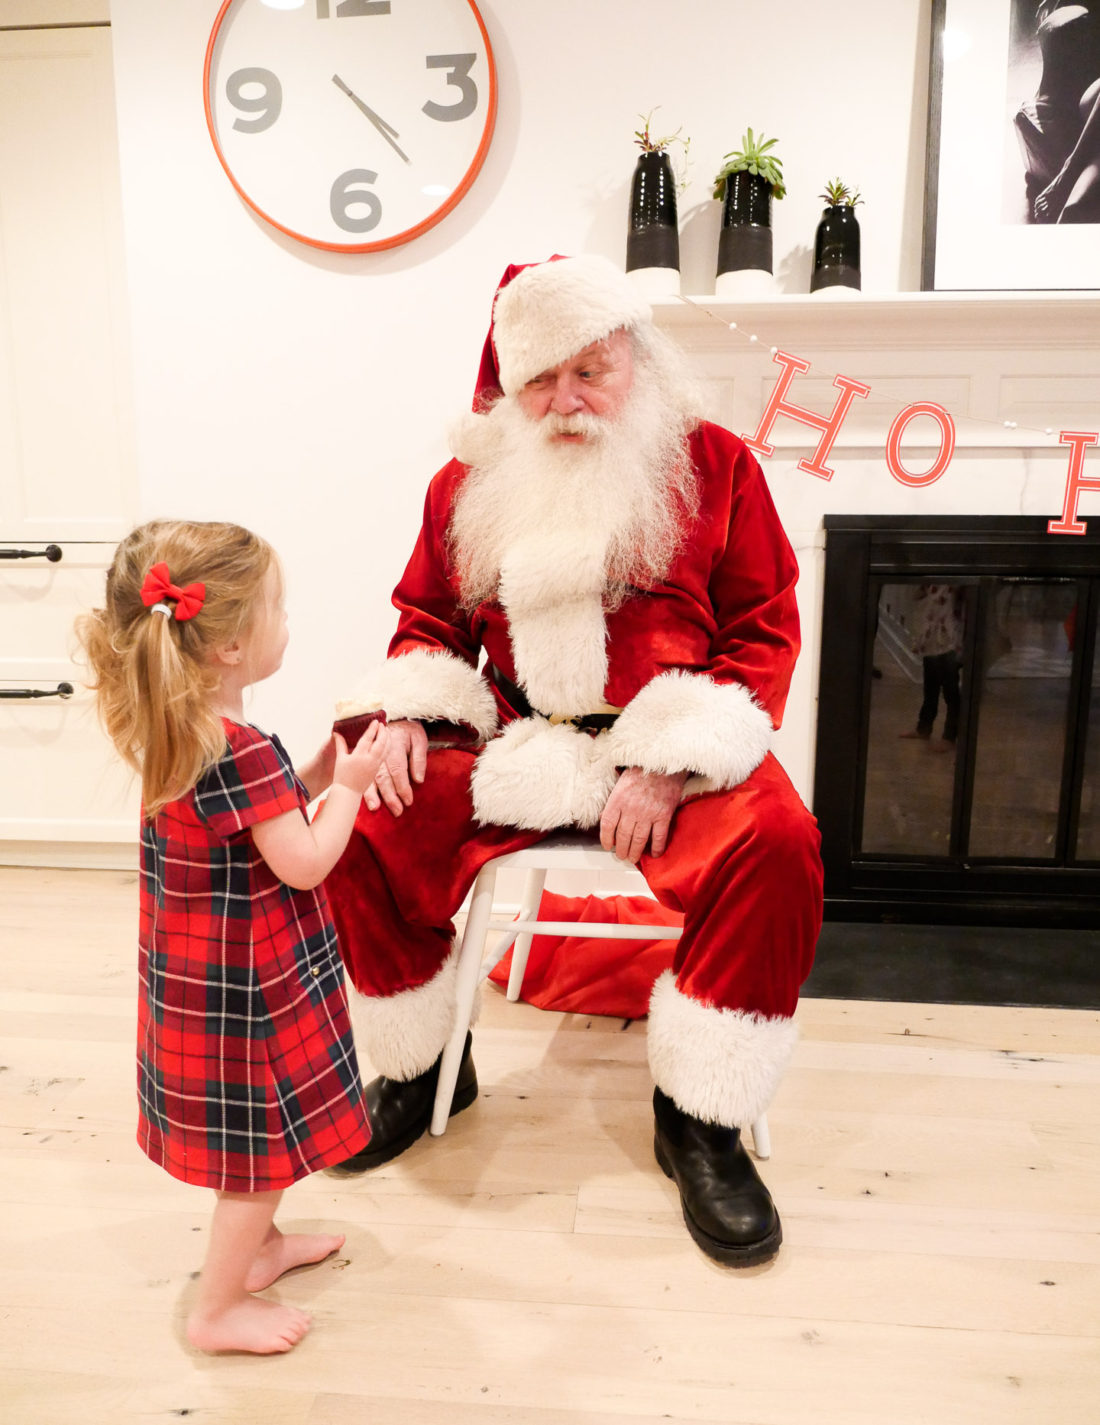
[970,579,1077,859]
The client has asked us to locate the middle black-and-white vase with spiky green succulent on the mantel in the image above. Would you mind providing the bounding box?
[714,128,787,296]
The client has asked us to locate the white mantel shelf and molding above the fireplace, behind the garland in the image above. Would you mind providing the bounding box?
[654,292,1100,460]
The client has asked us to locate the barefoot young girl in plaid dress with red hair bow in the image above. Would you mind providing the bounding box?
[78,520,386,1354]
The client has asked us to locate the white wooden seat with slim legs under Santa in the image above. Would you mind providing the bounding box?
[432,832,771,1159]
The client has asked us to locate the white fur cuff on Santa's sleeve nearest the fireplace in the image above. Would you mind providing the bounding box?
[610,673,772,791]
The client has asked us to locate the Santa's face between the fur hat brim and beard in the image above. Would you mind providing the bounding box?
[516,331,634,445]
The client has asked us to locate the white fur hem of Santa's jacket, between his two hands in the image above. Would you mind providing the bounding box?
[470,717,616,831]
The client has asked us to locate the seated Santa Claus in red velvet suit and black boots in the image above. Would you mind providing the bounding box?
[329,257,821,1265]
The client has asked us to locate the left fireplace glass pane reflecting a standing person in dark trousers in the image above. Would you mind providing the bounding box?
[862,583,966,856]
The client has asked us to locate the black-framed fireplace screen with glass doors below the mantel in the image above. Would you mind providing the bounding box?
[814,516,1100,925]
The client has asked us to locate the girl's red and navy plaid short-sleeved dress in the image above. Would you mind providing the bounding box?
[138,720,370,1193]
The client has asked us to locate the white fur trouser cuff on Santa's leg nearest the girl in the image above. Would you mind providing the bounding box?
[353,953,457,1080]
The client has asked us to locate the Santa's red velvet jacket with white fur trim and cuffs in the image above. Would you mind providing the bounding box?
[362,422,799,831]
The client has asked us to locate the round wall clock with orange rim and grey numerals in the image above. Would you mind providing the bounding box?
[204,0,496,252]
